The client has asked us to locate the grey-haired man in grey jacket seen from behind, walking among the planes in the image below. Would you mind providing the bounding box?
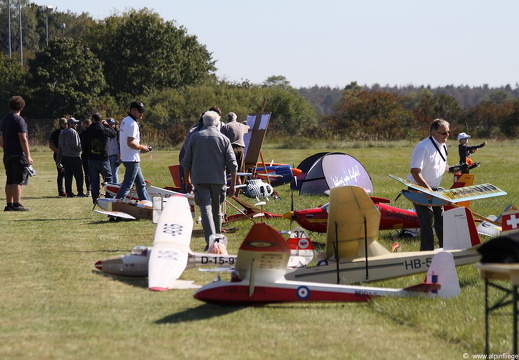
[181,111,238,250]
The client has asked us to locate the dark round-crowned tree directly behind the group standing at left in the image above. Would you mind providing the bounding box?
[29,39,106,118]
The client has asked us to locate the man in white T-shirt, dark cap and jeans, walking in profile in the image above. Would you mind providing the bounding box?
[115,101,151,200]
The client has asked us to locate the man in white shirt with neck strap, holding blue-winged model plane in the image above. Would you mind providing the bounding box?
[408,119,449,251]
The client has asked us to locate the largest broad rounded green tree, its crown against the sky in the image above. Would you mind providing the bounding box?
[88,8,215,96]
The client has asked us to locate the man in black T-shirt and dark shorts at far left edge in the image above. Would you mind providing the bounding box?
[0,96,32,211]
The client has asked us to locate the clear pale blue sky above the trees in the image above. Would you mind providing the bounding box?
[33,0,519,88]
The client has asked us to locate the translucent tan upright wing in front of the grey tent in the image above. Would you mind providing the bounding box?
[326,186,388,259]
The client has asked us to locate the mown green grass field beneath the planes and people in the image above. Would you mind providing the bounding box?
[0,140,519,359]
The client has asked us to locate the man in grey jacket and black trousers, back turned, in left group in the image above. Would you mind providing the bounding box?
[56,117,86,198]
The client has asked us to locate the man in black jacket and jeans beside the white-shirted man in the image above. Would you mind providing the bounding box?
[83,113,117,205]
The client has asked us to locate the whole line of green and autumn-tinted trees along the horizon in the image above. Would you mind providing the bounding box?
[0,0,519,146]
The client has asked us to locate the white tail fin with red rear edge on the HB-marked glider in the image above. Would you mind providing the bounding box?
[443,207,481,250]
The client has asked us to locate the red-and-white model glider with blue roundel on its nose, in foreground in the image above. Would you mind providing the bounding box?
[194,222,460,306]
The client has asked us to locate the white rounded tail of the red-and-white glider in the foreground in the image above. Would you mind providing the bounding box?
[404,251,460,298]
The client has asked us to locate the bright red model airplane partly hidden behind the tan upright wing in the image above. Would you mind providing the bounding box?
[283,196,420,233]
